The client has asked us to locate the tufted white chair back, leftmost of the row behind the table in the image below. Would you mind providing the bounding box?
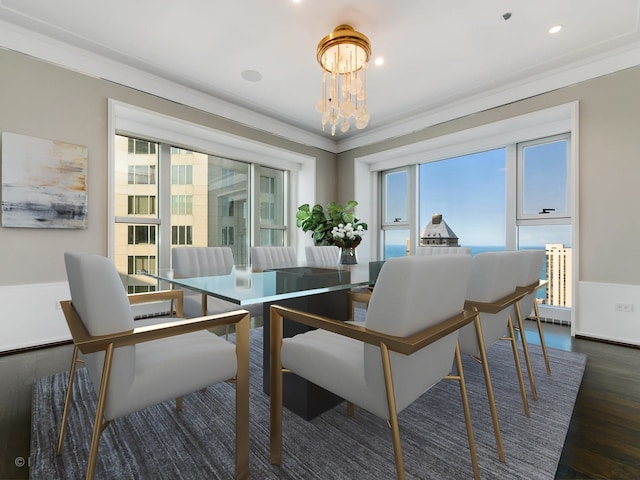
[171,247,234,278]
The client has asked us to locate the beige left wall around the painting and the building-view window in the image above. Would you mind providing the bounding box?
[0,50,336,286]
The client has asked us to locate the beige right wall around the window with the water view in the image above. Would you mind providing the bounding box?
[337,67,640,286]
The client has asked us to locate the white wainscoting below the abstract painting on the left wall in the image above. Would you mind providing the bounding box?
[0,282,71,352]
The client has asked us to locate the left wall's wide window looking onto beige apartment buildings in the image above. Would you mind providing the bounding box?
[112,131,287,292]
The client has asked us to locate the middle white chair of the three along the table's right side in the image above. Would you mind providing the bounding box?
[459,251,529,462]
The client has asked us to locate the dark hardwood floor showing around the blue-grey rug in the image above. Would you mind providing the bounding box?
[0,322,640,480]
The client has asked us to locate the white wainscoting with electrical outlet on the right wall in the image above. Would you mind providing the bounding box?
[575,282,640,345]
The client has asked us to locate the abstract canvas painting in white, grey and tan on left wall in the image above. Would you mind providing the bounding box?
[2,132,88,228]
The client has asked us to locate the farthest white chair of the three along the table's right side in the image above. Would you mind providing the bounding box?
[515,250,551,374]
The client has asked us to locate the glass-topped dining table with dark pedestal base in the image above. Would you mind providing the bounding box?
[145,261,384,420]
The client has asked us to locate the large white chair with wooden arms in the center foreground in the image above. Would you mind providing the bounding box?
[270,255,479,478]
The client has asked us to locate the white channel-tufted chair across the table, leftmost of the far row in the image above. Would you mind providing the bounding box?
[171,247,262,317]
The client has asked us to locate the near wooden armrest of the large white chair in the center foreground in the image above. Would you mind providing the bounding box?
[271,305,478,355]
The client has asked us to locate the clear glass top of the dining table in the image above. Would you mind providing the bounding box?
[147,262,382,305]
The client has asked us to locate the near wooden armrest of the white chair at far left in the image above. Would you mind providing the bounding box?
[60,300,250,354]
